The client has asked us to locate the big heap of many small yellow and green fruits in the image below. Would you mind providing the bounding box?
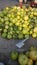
[0,6,37,39]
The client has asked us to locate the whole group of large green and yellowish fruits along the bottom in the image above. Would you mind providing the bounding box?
[10,46,37,65]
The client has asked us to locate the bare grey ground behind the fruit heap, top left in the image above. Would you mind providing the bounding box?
[0,0,18,9]
